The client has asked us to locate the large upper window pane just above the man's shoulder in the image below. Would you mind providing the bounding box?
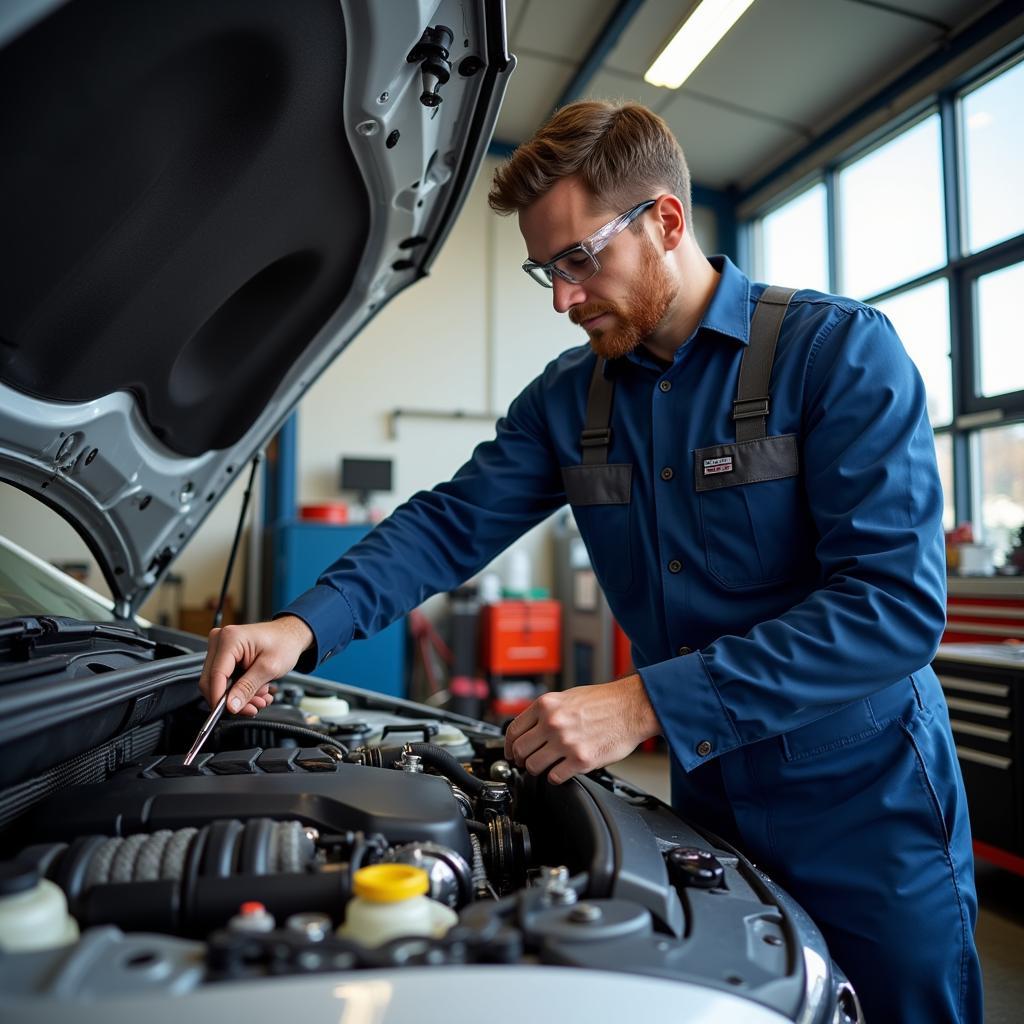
[839,114,946,299]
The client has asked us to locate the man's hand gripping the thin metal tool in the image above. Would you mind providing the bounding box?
[199,615,313,718]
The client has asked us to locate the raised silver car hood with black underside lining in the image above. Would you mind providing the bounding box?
[0,0,514,614]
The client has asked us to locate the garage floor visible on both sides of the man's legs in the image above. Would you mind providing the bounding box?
[609,754,1024,1024]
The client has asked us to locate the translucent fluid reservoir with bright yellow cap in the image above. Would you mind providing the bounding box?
[338,864,459,946]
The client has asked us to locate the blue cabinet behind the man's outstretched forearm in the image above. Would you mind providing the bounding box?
[268,521,406,697]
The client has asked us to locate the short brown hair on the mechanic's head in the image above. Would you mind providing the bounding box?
[487,99,691,225]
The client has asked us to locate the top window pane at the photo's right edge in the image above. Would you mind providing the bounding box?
[962,61,1024,252]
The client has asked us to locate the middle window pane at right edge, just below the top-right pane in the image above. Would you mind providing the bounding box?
[975,263,1024,395]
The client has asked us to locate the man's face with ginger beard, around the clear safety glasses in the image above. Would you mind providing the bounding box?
[519,178,679,359]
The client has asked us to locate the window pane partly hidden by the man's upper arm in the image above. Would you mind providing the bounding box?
[878,278,953,427]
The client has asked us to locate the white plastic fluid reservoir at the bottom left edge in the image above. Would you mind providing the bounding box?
[0,860,78,953]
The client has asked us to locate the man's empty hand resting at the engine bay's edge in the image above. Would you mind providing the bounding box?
[505,676,662,784]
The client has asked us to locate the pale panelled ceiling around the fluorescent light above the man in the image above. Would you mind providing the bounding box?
[498,0,1007,187]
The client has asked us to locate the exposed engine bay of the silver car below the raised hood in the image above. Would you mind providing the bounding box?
[0,655,851,1020]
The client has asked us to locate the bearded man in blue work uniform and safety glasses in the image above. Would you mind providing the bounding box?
[201,102,981,1024]
